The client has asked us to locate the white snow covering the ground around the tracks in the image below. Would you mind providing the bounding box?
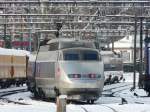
[0,74,150,112]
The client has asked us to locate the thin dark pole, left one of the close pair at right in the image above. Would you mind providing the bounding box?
[133,15,137,89]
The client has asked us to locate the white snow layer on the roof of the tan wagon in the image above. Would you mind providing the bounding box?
[0,48,30,56]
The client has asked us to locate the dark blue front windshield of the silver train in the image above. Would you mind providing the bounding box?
[63,50,99,61]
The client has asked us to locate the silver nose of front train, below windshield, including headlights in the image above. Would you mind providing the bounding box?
[59,61,104,88]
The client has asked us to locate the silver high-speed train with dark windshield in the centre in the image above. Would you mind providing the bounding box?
[27,39,104,103]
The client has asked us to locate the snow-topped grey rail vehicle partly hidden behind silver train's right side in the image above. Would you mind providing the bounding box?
[100,50,123,85]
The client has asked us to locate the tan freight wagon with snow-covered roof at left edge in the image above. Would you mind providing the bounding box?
[0,48,30,88]
